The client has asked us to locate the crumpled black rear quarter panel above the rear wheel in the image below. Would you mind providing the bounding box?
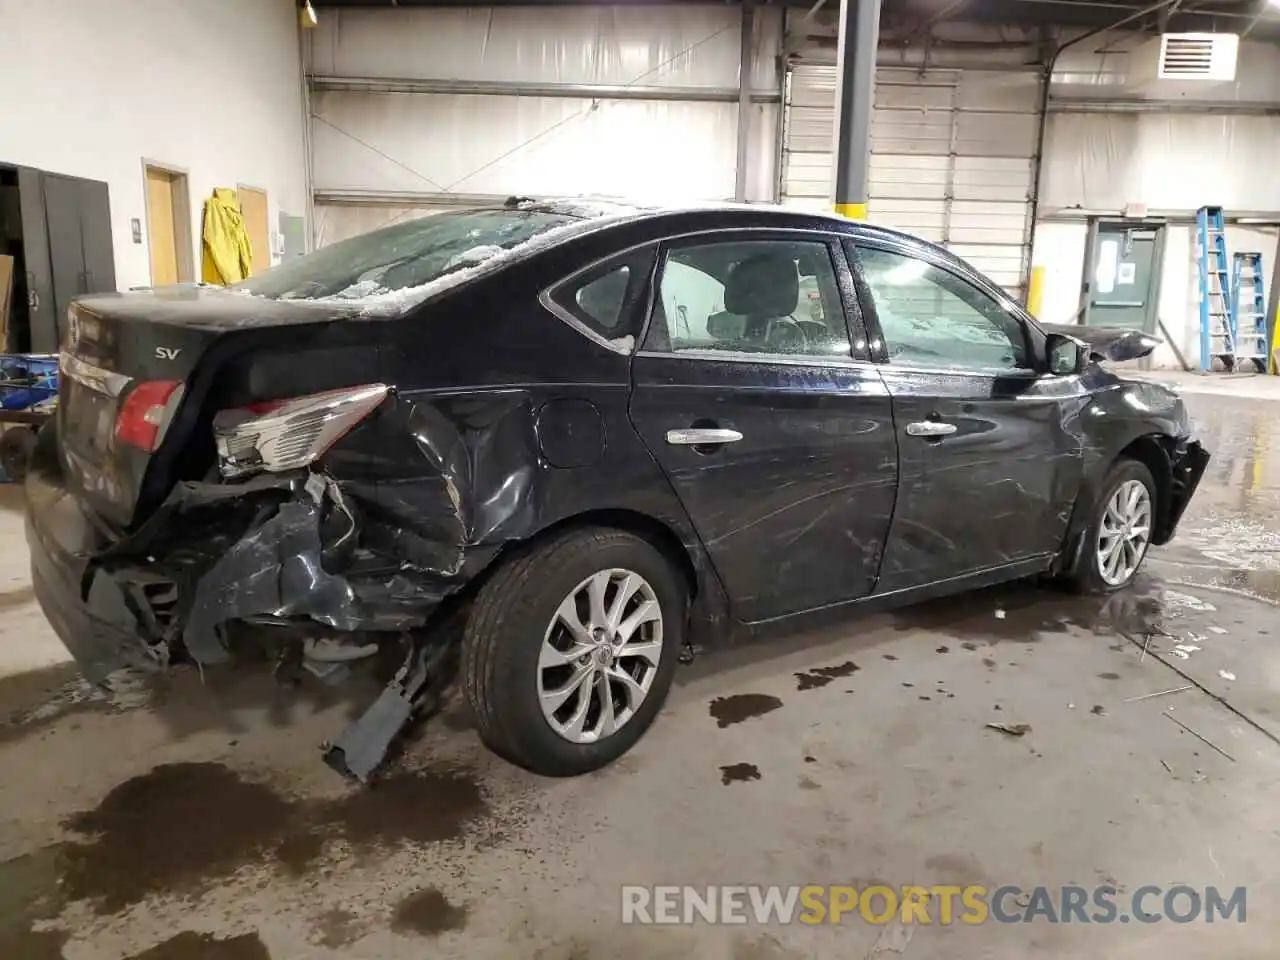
[350,259,718,616]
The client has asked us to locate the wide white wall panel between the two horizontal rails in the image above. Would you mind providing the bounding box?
[312,91,737,201]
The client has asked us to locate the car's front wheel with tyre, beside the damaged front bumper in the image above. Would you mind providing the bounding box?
[1068,458,1156,593]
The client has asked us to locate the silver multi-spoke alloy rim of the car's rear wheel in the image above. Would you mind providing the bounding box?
[538,568,662,744]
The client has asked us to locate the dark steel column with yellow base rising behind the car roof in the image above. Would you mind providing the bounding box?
[835,0,881,220]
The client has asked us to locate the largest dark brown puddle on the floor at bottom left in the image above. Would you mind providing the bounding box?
[0,763,489,960]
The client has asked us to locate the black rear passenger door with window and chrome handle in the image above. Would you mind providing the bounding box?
[630,233,897,621]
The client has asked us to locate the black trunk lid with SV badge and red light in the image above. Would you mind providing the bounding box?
[58,285,358,530]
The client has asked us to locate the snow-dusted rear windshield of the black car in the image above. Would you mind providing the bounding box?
[236,210,577,300]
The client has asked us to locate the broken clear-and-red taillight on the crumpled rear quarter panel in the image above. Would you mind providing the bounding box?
[214,383,389,479]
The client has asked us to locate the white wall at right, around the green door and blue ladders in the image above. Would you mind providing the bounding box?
[1033,37,1280,367]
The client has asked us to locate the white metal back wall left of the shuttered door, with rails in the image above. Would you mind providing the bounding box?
[308,5,781,242]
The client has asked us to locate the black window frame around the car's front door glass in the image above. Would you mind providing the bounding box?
[844,236,1044,380]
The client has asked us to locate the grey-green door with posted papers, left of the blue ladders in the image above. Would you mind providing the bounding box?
[1084,220,1160,333]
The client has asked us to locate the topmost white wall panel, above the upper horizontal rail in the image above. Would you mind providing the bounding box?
[311,5,781,90]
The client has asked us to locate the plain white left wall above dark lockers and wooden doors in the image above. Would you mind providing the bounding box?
[0,0,307,288]
